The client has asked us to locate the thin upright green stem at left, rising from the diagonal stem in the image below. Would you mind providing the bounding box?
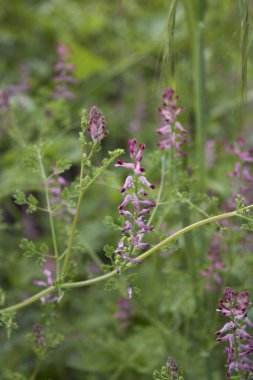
[38,150,60,280]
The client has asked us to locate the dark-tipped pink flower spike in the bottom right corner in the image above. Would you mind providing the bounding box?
[216,288,253,378]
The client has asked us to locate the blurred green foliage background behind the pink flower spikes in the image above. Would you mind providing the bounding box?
[0,0,253,380]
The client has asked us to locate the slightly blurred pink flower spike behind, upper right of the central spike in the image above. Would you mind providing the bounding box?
[156,88,187,156]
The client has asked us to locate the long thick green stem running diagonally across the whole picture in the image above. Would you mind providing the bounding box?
[0,204,253,314]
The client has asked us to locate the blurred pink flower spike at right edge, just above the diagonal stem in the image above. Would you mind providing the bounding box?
[228,137,253,208]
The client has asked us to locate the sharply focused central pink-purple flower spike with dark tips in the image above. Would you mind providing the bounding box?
[115,139,156,263]
